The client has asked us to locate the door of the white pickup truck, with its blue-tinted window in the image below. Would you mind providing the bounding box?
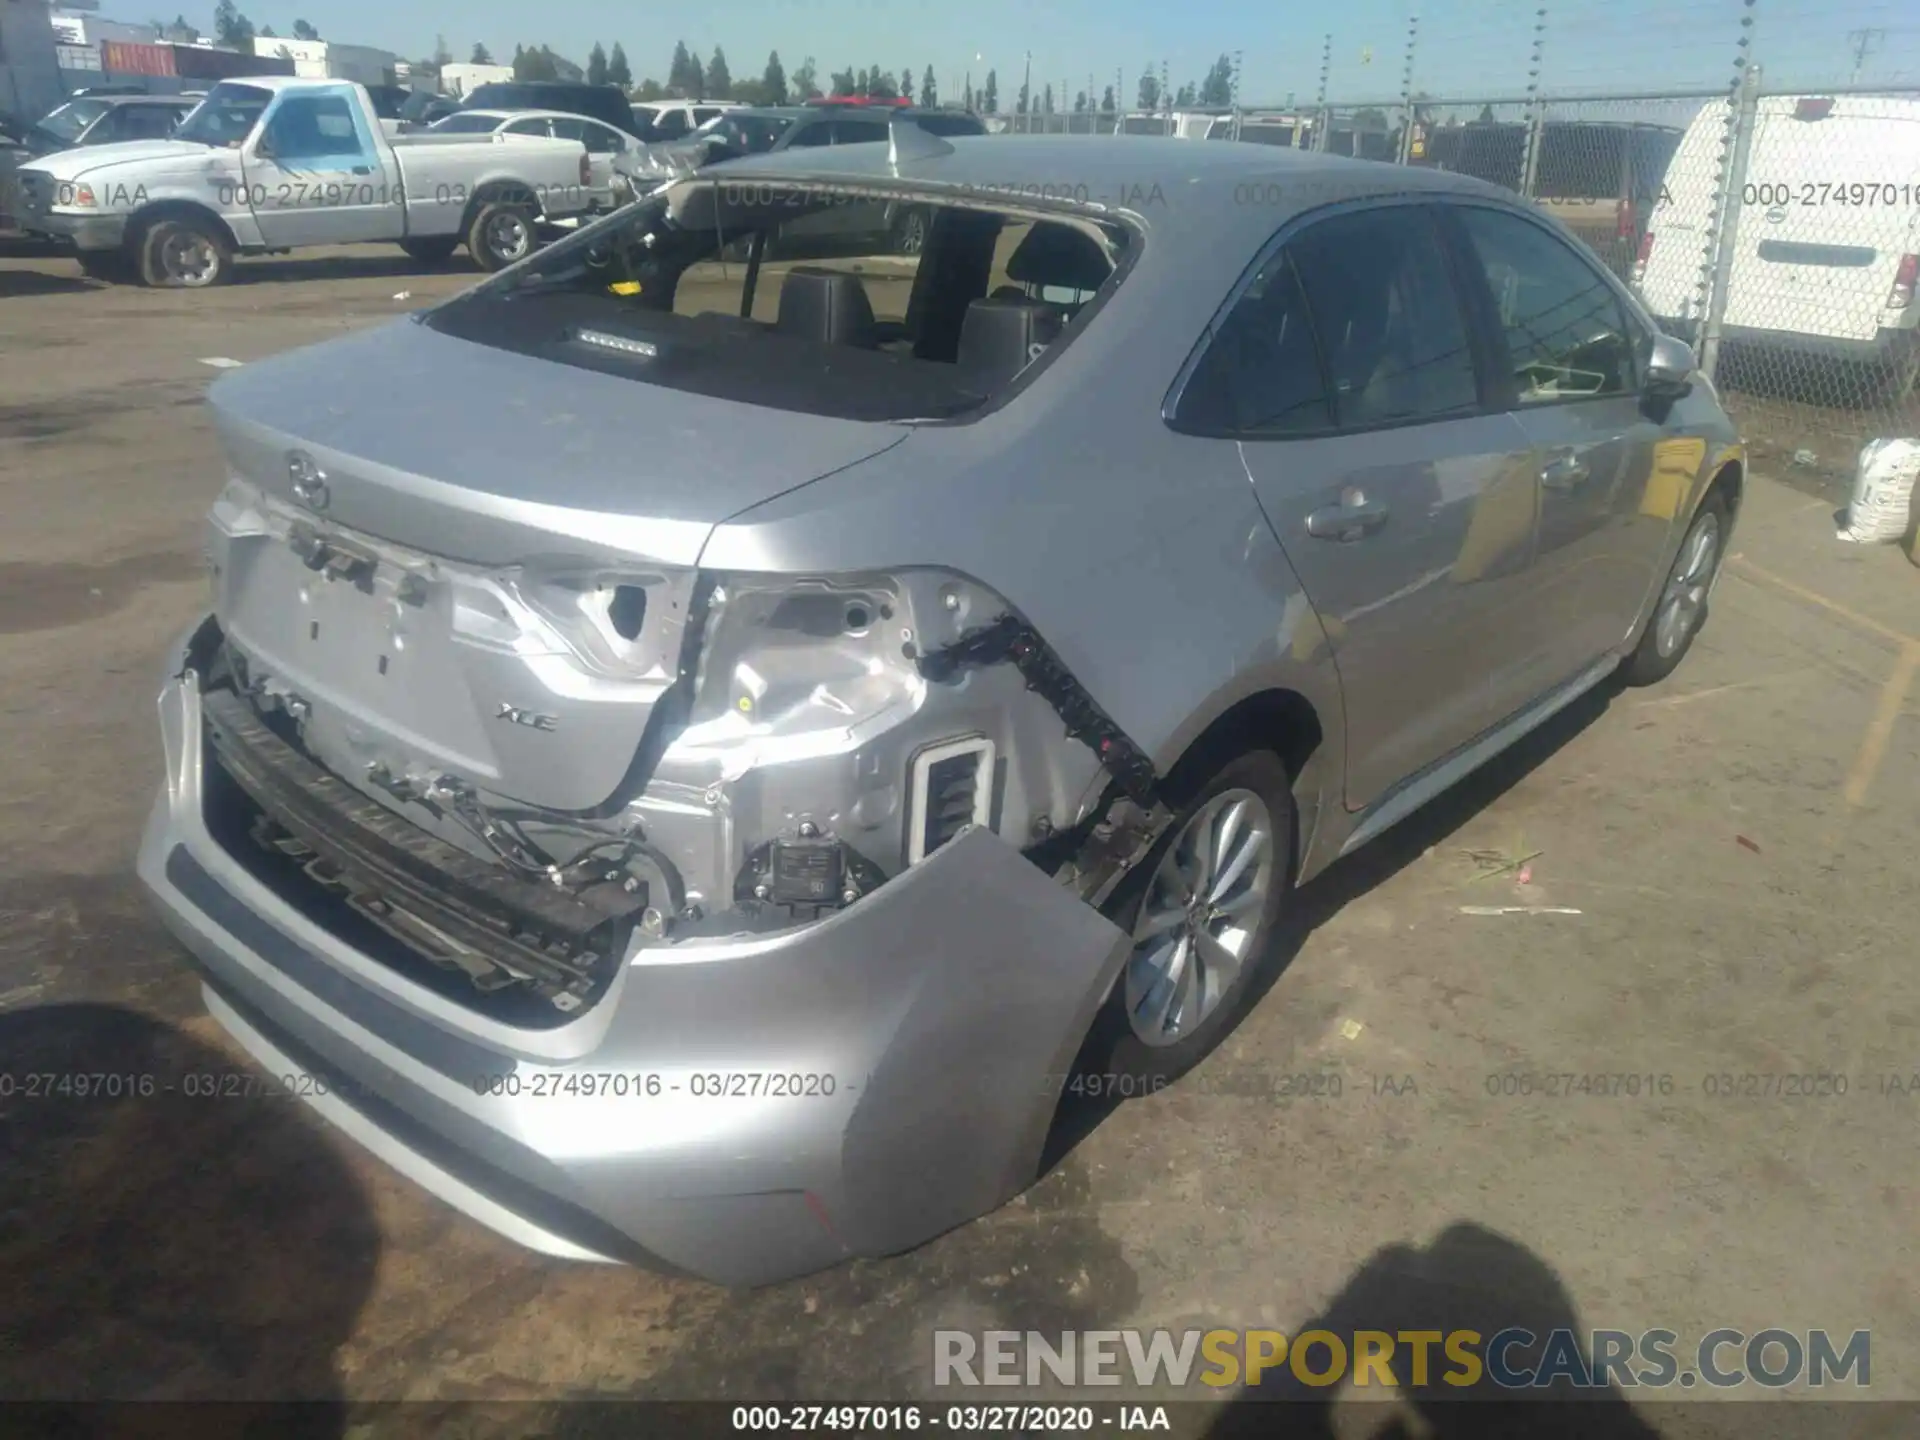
[242,84,407,248]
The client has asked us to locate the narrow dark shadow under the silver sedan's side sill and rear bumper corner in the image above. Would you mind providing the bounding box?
[1041,680,1620,1175]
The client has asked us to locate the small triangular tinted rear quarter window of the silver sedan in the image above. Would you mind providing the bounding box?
[1177,252,1332,436]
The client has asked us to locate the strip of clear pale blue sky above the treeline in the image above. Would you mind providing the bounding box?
[165,0,1920,109]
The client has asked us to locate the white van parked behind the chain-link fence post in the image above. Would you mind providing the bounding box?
[1634,96,1920,396]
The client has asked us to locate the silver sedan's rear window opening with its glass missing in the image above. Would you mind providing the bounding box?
[424,179,1135,420]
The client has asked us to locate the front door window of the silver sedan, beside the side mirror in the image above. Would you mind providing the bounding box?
[1455,205,1634,405]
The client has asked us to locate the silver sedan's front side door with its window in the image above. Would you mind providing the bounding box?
[1442,204,1674,710]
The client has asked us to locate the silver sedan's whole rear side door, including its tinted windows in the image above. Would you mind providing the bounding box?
[1205,204,1536,810]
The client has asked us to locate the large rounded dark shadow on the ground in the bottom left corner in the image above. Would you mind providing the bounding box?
[0,1006,380,1436]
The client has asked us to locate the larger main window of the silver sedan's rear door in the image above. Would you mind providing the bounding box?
[1288,205,1478,428]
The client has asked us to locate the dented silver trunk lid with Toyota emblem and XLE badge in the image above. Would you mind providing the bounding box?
[209,323,904,812]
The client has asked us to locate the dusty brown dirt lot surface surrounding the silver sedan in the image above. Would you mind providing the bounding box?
[0,250,1920,1434]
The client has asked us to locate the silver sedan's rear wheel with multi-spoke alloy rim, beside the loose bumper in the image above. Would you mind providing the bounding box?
[1075,751,1294,1098]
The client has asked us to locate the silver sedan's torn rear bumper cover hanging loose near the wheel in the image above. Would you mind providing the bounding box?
[138,629,1127,1284]
